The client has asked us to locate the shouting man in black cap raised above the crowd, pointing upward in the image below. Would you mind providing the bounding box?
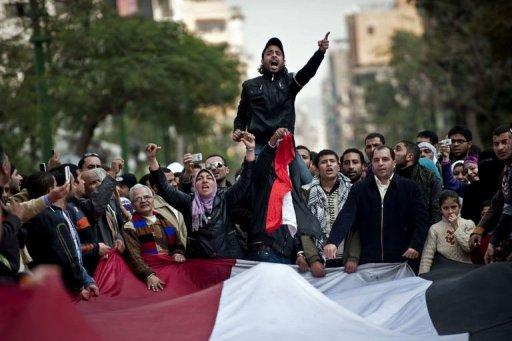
[232,32,329,185]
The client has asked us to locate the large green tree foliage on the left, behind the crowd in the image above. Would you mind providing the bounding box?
[0,0,240,170]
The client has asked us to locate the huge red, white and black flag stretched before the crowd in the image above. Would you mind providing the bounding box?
[0,253,512,340]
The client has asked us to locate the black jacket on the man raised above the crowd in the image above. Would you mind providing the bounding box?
[234,51,324,144]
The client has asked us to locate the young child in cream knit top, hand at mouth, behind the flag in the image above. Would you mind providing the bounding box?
[419,190,475,274]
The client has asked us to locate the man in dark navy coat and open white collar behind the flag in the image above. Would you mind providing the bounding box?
[324,146,430,271]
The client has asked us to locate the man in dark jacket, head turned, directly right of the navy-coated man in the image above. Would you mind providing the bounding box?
[394,140,441,225]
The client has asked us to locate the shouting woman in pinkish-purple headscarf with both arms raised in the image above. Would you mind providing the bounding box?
[146,132,255,258]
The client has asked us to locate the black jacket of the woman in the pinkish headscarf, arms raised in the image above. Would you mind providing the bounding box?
[151,162,254,258]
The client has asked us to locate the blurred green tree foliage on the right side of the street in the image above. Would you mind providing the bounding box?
[365,0,512,146]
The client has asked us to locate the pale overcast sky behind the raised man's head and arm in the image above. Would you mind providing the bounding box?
[227,0,393,109]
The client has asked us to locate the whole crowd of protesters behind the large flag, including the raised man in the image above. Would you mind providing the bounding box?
[0,34,512,299]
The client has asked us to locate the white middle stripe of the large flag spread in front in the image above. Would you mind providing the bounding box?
[211,261,467,341]
